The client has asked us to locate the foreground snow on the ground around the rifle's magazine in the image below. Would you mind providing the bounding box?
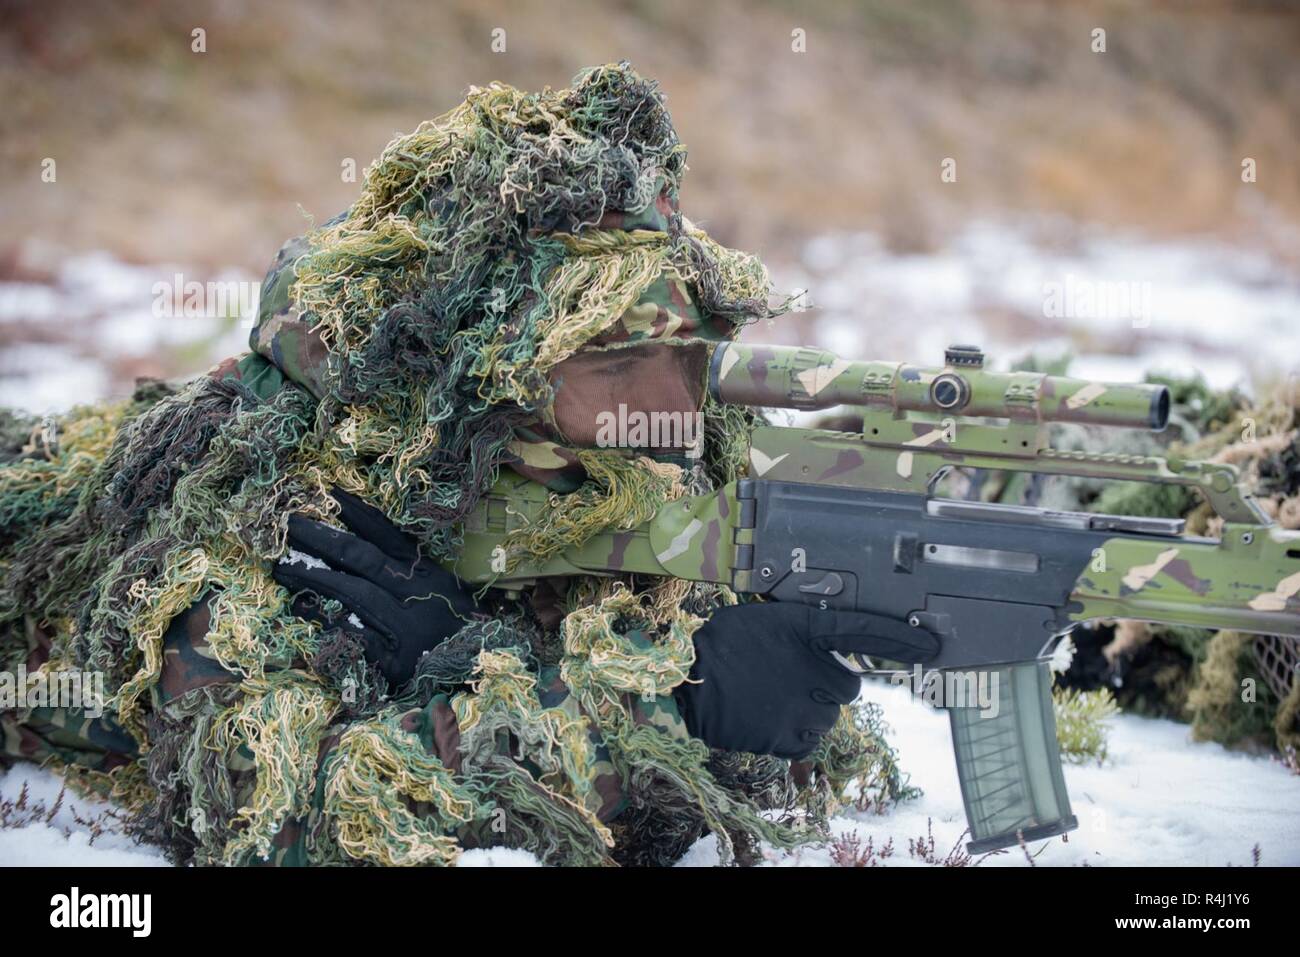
[681,681,1300,867]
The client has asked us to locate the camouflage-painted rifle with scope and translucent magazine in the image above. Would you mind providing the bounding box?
[455,343,1300,852]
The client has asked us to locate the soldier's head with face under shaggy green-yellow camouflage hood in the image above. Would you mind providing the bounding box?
[244,64,767,546]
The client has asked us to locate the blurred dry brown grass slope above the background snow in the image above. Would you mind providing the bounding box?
[0,0,1300,270]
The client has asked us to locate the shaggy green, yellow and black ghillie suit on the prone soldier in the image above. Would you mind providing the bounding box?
[0,65,906,865]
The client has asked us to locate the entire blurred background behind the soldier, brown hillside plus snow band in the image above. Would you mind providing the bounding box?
[0,0,1300,411]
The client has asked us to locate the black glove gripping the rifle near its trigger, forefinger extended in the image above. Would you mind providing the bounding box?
[673,602,939,759]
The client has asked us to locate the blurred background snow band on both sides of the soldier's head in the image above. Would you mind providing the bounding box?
[0,218,1300,413]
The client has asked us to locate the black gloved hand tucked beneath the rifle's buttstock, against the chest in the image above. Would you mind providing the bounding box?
[272,489,477,688]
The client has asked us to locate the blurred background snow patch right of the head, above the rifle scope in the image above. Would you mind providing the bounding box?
[764,221,1300,387]
